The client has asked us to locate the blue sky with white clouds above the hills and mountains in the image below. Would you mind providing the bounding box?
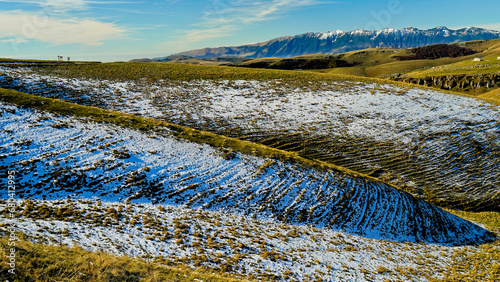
[0,0,500,61]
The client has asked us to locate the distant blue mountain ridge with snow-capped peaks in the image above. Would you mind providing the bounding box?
[171,26,500,60]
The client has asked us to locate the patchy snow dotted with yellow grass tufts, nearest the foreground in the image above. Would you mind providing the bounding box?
[0,200,464,281]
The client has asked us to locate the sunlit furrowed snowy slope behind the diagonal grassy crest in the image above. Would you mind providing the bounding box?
[0,67,500,211]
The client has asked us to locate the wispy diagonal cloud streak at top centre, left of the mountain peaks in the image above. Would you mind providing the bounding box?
[175,0,322,42]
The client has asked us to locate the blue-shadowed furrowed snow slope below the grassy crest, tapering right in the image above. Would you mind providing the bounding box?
[0,103,494,244]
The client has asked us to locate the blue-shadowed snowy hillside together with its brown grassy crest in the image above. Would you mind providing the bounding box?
[0,88,492,244]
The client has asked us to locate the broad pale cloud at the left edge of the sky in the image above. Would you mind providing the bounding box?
[0,11,126,46]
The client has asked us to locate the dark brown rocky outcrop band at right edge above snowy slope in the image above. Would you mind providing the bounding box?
[390,74,500,92]
